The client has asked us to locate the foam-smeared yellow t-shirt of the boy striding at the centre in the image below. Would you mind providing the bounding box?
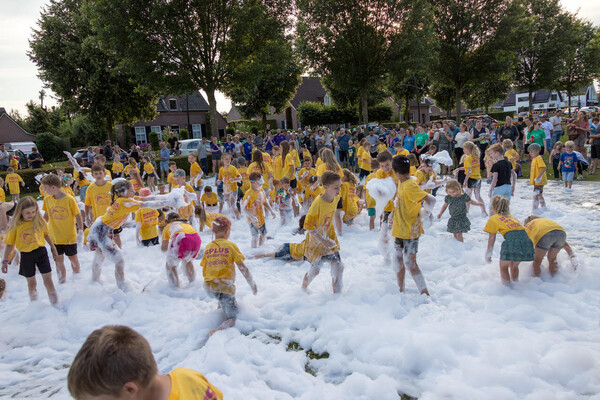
[304,195,343,262]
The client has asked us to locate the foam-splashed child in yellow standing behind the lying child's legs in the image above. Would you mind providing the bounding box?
[242,172,275,247]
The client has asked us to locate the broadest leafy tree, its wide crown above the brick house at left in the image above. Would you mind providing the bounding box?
[90,0,290,136]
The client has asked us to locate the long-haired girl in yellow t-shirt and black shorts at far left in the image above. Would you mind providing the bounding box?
[2,196,58,304]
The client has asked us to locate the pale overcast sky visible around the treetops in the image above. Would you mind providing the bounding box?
[0,0,600,115]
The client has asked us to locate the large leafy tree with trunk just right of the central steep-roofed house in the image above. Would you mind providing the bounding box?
[296,0,426,123]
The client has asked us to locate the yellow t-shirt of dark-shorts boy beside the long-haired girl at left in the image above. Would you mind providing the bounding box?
[42,194,79,244]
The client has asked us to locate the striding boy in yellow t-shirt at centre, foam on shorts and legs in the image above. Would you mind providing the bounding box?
[302,171,344,293]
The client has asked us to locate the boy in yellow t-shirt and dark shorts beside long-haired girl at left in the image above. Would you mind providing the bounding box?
[42,174,83,283]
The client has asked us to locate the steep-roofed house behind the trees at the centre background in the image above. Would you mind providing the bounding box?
[227,76,331,129]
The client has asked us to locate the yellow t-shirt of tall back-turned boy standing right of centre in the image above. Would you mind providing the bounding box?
[392,179,428,239]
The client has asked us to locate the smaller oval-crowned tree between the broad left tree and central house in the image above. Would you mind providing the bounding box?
[224,6,302,129]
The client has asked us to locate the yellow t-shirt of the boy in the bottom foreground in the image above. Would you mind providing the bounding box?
[167,368,223,400]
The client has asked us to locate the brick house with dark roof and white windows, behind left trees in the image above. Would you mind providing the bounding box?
[117,91,227,144]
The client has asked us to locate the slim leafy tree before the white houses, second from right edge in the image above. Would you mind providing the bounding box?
[514,0,568,112]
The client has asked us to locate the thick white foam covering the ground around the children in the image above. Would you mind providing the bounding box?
[0,181,600,400]
